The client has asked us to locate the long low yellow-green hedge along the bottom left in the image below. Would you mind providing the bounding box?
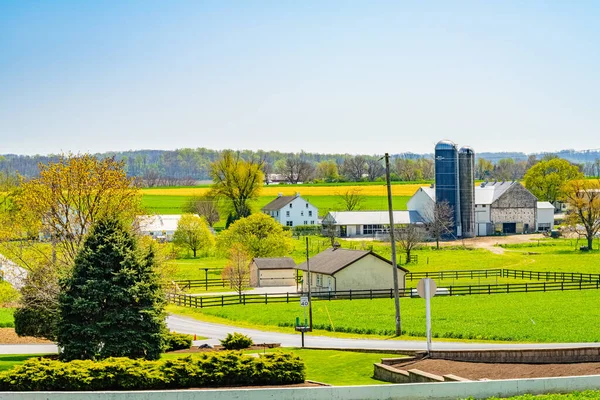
[0,352,305,391]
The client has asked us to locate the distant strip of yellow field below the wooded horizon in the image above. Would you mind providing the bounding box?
[142,183,426,196]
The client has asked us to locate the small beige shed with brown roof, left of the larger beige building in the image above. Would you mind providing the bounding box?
[250,257,297,287]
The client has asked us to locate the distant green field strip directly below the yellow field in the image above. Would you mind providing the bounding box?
[142,194,410,218]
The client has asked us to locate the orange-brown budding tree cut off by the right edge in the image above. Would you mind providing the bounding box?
[563,179,600,250]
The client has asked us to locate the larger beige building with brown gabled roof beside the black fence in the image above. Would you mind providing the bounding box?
[296,248,408,292]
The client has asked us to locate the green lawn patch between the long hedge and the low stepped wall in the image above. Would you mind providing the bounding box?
[162,348,400,386]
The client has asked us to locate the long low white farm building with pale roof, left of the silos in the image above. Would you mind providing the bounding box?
[322,211,424,238]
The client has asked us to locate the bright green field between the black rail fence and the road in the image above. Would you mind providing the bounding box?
[169,290,600,342]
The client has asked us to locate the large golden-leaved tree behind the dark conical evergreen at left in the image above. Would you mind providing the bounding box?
[0,154,141,338]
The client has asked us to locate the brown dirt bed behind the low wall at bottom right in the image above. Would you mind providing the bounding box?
[393,359,600,380]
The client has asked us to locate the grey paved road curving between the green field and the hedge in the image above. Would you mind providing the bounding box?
[0,315,600,354]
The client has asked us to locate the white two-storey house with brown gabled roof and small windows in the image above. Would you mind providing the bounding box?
[262,193,319,226]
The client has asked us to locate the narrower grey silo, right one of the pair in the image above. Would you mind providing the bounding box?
[458,146,475,237]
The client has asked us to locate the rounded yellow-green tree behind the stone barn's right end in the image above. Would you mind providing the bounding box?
[525,158,583,203]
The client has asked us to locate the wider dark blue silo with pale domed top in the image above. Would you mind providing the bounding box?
[435,140,462,237]
